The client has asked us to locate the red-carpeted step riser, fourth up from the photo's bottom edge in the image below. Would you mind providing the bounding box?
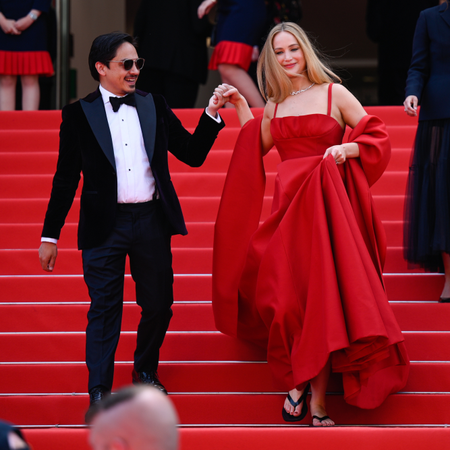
[0,331,450,363]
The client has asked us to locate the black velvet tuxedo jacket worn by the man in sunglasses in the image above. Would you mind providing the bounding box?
[42,90,225,249]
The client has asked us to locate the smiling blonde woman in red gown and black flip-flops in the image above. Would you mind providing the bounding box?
[213,23,409,426]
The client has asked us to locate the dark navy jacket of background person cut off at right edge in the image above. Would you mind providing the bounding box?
[406,3,450,120]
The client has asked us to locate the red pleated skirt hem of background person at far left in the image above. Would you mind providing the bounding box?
[0,50,55,77]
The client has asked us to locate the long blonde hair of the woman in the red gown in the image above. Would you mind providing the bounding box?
[257,22,342,103]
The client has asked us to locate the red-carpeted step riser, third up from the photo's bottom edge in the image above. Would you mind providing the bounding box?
[0,362,450,396]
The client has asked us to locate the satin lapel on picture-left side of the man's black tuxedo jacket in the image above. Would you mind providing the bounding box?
[80,95,116,170]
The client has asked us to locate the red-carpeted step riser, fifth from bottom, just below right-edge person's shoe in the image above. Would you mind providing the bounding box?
[0,302,450,333]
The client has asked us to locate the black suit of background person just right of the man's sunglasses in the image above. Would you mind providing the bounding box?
[134,0,211,88]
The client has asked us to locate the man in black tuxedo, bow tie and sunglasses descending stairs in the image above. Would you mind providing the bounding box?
[39,33,224,421]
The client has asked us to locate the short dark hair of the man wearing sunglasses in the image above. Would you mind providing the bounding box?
[89,31,136,81]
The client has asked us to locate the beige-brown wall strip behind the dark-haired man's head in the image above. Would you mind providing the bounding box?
[70,0,126,98]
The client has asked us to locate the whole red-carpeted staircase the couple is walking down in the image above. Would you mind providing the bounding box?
[0,107,450,450]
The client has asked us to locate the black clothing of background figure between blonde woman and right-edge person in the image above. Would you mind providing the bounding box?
[366,0,438,105]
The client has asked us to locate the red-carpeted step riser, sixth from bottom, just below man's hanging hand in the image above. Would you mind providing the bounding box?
[0,270,444,306]
